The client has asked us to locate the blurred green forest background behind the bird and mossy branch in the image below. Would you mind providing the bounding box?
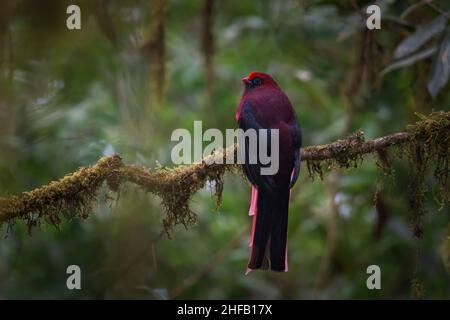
[0,0,450,299]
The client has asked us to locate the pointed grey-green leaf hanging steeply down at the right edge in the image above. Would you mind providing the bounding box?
[428,26,450,98]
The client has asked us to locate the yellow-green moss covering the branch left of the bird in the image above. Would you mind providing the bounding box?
[0,148,243,235]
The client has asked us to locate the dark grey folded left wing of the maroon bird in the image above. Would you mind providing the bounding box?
[239,102,275,191]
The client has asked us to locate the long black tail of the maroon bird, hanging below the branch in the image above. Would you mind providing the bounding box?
[247,189,289,272]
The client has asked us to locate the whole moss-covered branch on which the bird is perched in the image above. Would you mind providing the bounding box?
[0,112,450,232]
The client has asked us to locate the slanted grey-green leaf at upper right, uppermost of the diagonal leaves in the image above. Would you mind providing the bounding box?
[394,16,447,59]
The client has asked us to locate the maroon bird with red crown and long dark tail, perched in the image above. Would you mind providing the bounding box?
[236,72,302,273]
